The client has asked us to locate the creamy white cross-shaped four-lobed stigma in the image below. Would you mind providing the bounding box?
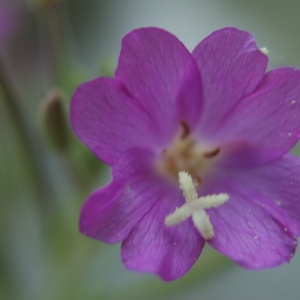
[165,171,229,240]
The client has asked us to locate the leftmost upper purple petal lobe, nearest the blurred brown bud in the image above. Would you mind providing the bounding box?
[71,77,159,164]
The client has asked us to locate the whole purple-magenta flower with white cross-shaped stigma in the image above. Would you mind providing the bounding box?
[71,28,300,280]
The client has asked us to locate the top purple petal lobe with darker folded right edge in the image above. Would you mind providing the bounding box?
[116,28,202,142]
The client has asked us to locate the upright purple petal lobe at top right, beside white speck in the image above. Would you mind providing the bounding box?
[193,28,268,138]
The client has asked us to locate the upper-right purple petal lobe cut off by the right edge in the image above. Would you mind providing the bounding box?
[214,68,300,164]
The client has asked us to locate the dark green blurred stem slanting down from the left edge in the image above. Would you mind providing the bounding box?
[0,58,53,213]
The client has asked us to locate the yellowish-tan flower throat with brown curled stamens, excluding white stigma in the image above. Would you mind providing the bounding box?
[158,121,221,184]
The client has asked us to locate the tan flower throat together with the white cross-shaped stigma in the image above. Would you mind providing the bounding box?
[157,121,229,240]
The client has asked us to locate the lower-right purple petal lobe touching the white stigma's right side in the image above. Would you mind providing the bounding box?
[210,197,297,269]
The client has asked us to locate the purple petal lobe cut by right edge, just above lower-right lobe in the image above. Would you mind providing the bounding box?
[227,155,300,236]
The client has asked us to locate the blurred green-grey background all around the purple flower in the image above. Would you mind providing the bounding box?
[0,0,300,300]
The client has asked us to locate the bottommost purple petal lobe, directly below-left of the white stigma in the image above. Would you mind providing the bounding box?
[122,189,204,281]
